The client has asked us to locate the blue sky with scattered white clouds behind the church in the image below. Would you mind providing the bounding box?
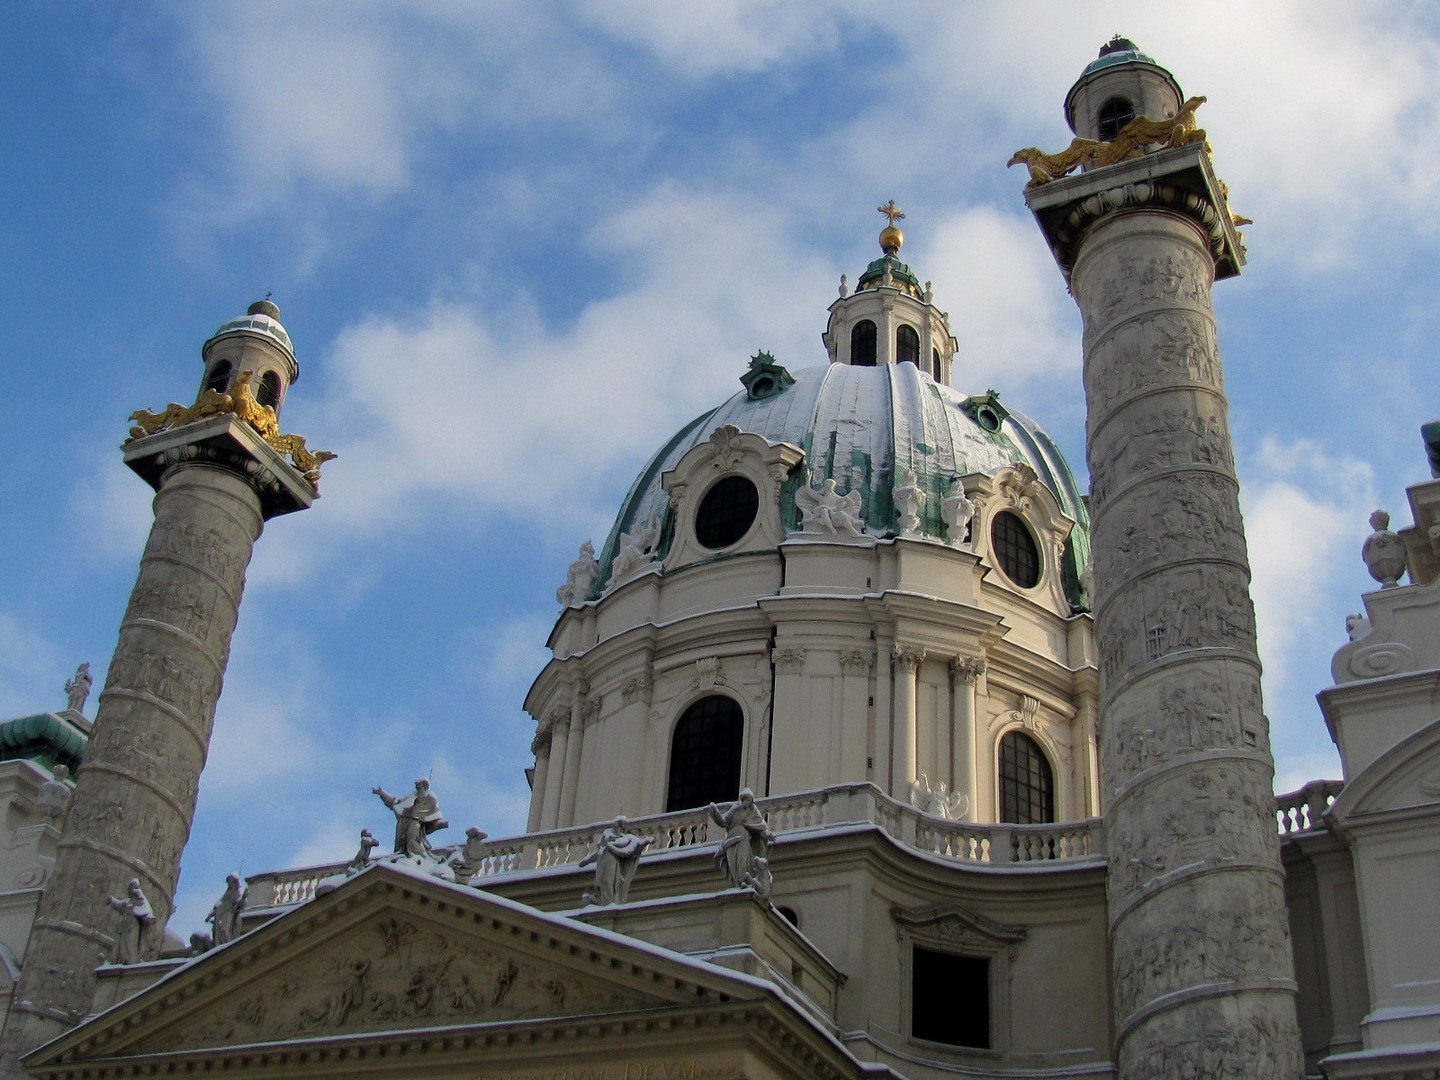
[0,0,1440,933]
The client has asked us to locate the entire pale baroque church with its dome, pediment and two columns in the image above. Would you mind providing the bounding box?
[0,39,1440,1080]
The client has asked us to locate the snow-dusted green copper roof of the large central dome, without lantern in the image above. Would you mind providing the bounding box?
[596,364,1090,608]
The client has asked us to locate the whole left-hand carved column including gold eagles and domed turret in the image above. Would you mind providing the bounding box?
[0,301,333,1076]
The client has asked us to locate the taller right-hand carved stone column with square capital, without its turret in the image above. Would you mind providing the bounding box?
[1027,133,1300,1080]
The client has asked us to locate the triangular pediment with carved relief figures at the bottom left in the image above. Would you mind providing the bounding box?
[36,865,755,1067]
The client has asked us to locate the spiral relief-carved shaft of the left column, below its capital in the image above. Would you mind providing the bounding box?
[4,464,264,1068]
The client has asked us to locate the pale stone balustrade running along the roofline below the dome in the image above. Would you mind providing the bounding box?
[249,780,1342,912]
